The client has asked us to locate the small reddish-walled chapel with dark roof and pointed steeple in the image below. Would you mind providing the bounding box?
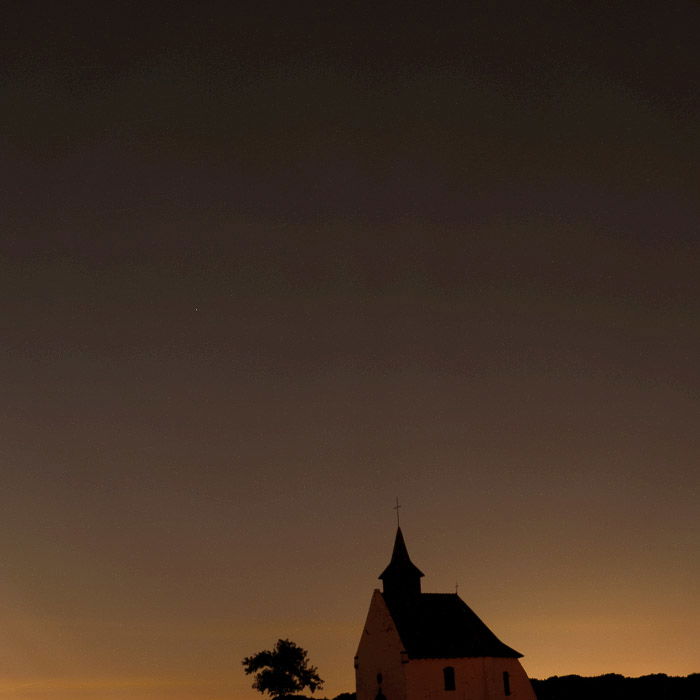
[355,527,536,700]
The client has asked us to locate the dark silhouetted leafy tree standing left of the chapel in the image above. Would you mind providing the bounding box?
[242,639,323,698]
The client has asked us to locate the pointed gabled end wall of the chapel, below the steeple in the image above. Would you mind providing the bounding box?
[355,590,407,700]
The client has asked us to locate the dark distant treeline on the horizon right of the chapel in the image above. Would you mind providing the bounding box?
[531,673,700,700]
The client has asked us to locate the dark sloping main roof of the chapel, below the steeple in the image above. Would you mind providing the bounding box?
[385,592,522,659]
